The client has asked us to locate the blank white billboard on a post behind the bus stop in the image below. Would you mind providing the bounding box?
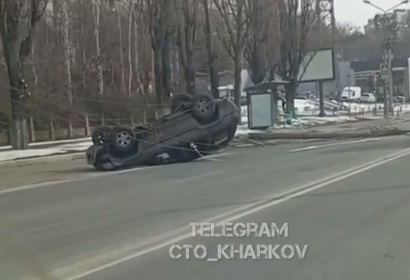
[299,49,335,83]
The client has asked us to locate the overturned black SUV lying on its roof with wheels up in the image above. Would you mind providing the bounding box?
[86,94,240,170]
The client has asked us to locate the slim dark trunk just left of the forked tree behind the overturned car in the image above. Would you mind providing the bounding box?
[202,0,219,97]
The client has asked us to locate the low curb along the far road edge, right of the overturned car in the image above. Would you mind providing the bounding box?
[249,130,409,141]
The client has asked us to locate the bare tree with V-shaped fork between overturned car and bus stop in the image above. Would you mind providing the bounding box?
[213,0,249,107]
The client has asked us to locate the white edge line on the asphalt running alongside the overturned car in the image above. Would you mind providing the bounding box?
[0,153,231,196]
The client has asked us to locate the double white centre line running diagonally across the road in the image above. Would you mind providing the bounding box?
[60,149,410,280]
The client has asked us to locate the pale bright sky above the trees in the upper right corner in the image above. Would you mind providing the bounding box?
[334,0,410,27]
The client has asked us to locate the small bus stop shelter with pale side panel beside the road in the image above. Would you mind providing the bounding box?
[244,81,289,129]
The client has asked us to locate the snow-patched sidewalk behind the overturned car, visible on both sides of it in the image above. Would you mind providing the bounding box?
[0,105,410,163]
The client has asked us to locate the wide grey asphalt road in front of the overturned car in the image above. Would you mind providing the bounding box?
[0,137,410,280]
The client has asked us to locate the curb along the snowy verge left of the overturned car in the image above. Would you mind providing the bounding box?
[0,151,85,168]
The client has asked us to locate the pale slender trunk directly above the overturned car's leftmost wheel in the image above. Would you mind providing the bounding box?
[93,0,104,96]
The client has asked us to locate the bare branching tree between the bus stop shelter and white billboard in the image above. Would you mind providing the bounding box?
[276,0,316,113]
